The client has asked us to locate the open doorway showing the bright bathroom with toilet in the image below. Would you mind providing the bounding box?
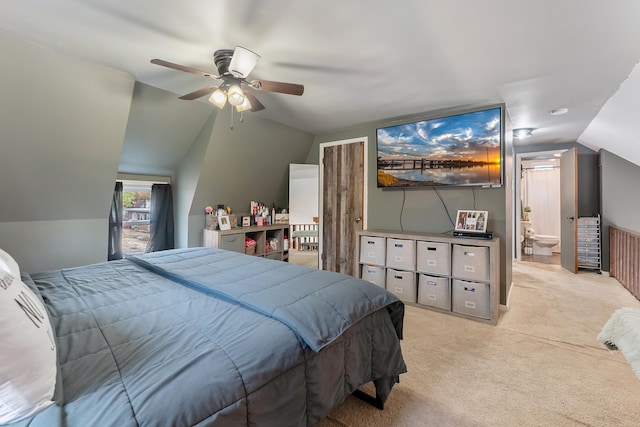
[514,150,566,265]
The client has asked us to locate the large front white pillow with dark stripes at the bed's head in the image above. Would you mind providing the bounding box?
[0,270,57,424]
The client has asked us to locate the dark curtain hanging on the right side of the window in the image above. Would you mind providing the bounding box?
[145,184,174,252]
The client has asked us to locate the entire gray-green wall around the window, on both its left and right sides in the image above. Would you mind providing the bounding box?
[0,35,314,272]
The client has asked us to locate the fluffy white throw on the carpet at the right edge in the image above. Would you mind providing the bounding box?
[598,308,640,378]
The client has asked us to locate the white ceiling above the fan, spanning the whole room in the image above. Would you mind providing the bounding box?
[0,0,640,164]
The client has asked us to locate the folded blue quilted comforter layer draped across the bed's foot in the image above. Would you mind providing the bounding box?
[127,248,402,351]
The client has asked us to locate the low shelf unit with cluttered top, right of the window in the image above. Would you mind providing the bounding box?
[202,224,289,261]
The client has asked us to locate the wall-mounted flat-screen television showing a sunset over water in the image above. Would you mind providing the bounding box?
[376,106,504,188]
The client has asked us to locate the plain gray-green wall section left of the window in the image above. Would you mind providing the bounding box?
[0,36,134,271]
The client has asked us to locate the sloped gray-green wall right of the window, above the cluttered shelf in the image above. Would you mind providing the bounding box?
[176,108,314,247]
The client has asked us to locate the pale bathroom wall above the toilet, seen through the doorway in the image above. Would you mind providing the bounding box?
[521,158,561,252]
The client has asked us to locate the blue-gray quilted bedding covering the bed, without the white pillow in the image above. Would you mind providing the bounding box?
[0,248,406,427]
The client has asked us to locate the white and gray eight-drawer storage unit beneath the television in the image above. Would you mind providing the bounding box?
[355,230,500,325]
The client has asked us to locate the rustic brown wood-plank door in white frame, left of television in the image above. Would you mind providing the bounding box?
[320,141,365,275]
